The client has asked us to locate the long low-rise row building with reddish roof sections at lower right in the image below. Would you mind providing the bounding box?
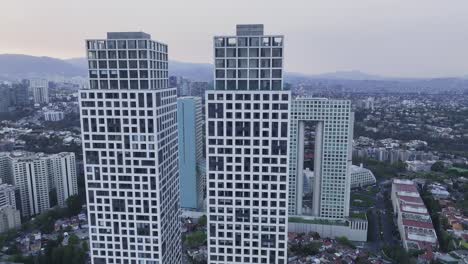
[391,179,438,250]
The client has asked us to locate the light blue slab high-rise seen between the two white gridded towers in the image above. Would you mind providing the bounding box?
[177,97,205,210]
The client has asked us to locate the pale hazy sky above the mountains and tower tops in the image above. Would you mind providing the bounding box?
[0,0,468,77]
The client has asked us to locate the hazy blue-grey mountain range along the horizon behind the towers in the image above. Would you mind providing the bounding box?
[0,54,462,82]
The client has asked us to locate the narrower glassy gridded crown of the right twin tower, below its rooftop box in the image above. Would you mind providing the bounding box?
[214,36,283,90]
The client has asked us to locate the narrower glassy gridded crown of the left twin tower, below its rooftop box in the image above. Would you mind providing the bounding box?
[86,39,168,90]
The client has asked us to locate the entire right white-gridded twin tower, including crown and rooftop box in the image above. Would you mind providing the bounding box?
[206,25,291,264]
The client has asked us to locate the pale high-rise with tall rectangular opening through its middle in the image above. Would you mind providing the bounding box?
[289,98,354,220]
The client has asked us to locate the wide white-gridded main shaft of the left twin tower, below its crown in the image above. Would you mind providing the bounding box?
[80,89,182,264]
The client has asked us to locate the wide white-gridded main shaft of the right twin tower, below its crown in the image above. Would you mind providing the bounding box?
[206,91,291,264]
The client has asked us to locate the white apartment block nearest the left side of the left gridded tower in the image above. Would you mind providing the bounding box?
[47,152,78,207]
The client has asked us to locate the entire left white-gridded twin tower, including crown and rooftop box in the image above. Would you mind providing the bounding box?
[80,32,182,264]
